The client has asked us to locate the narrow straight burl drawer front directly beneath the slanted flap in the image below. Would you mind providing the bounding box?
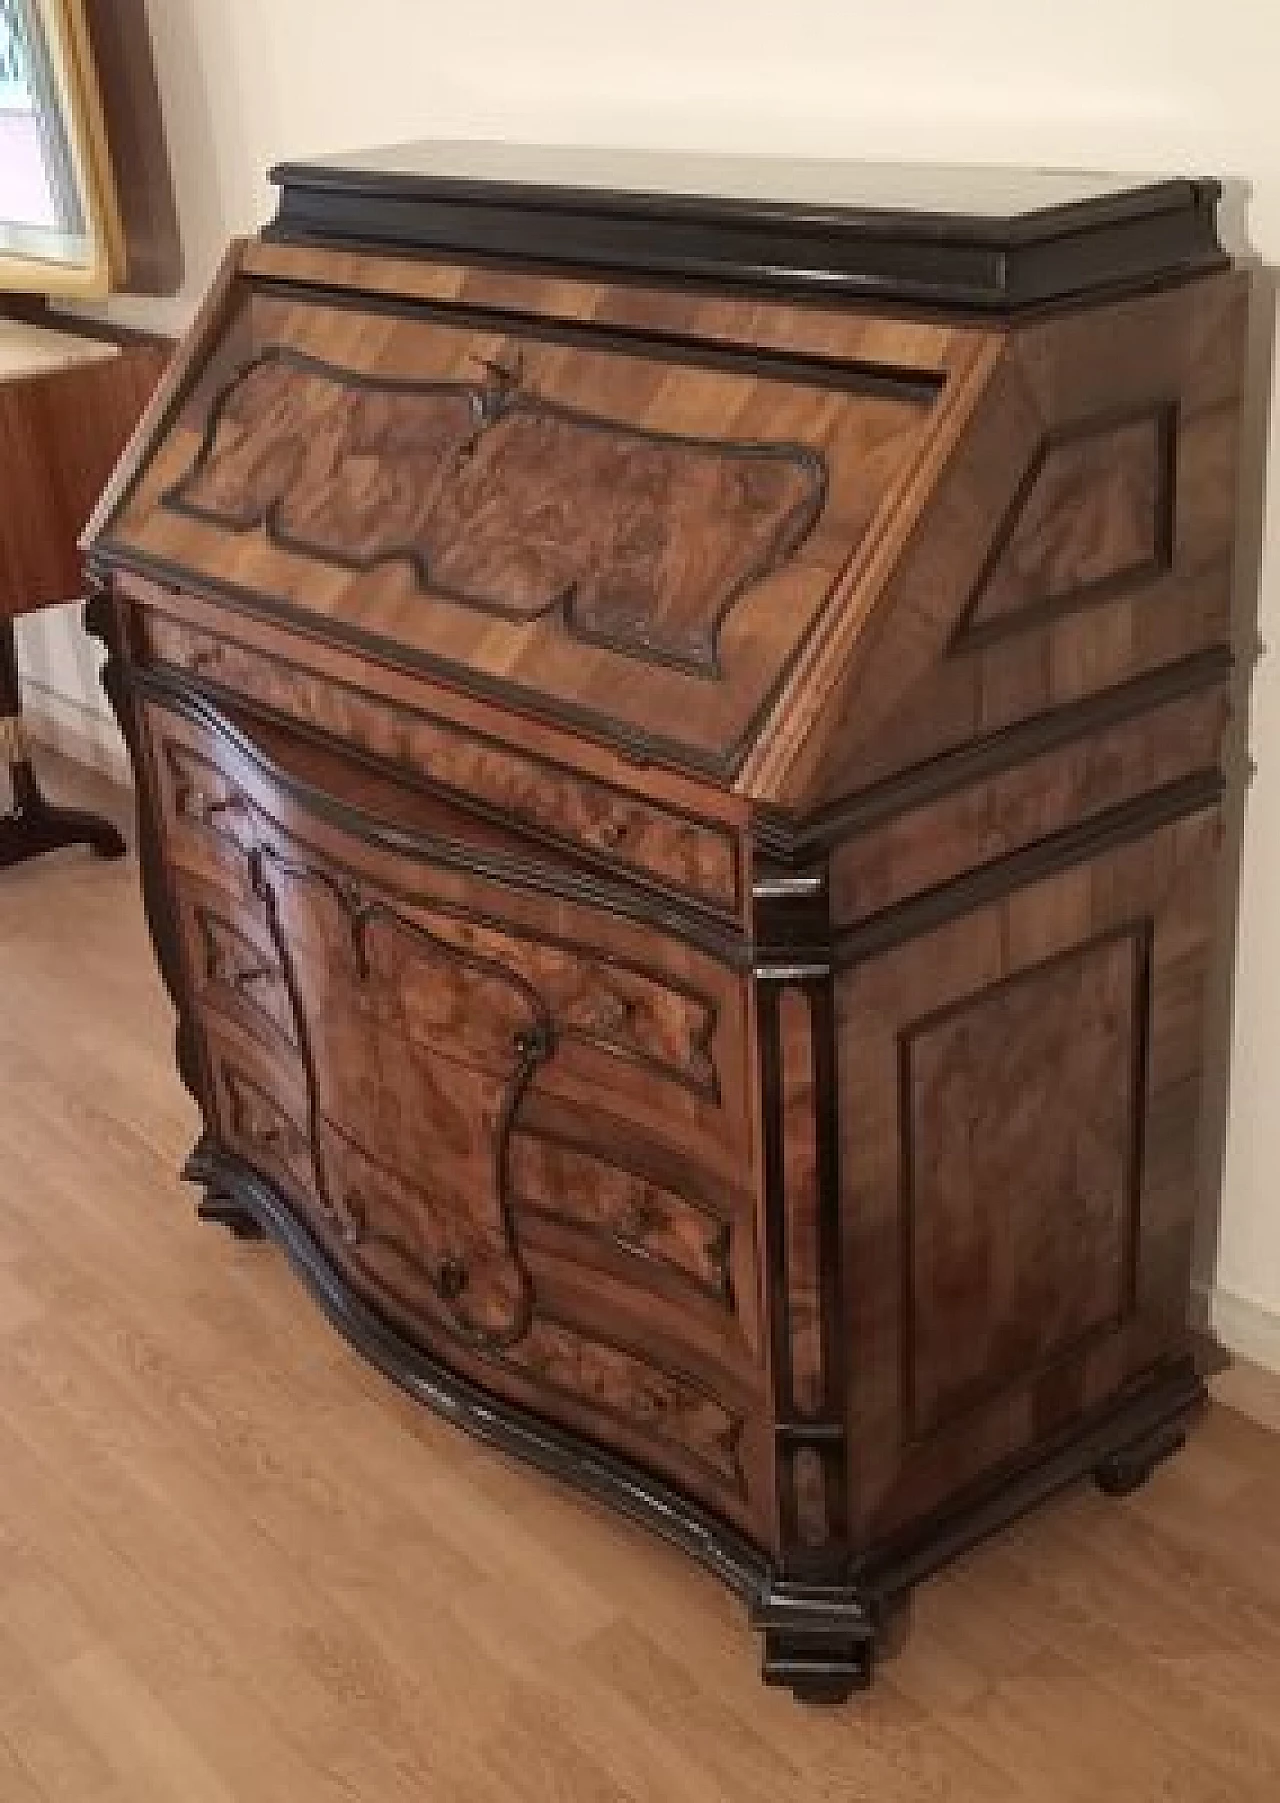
[142,613,741,912]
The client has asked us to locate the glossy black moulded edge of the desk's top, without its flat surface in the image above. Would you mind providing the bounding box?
[263,164,1226,316]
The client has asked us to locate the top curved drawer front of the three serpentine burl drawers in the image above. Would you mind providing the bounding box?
[148,707,752,1183]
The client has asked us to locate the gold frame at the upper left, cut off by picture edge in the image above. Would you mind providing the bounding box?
[0,0,124,299]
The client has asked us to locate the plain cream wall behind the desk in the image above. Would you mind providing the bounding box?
[27,0,1280,1367]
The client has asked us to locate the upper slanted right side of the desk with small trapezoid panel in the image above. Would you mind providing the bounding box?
[778,272,1248,810]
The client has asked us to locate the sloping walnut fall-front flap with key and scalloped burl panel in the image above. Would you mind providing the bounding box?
[97,257,995,777]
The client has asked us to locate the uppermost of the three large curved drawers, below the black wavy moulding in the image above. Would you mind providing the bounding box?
[146,701,752,1190]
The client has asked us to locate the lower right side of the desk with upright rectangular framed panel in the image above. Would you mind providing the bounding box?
[837,811,1219,1540]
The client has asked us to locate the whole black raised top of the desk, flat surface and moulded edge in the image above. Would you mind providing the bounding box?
[265,141,1226,314]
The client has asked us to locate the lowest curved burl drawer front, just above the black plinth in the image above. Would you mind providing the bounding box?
[204,1017,768,1533]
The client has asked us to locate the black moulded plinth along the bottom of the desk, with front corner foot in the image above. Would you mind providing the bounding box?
[184,1136,1204,1704]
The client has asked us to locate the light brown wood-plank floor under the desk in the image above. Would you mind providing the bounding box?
[0,753,1280,1803]
